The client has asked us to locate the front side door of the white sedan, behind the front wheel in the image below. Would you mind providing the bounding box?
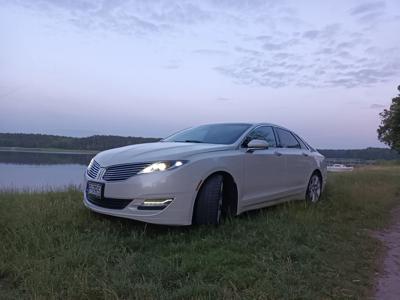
[242,126,286,207]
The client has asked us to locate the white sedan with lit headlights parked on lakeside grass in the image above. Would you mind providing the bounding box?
[84,123,327,225]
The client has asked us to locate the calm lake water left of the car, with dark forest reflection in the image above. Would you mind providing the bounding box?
[0,151,93,190]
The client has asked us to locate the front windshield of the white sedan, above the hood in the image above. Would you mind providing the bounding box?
[162,124,251,145]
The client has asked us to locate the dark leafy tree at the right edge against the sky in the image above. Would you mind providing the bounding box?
[377,85,400,152]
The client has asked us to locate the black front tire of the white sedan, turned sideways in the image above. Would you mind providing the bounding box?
[193,174,224,225]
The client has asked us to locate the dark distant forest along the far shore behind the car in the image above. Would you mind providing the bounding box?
[0,133,400,160]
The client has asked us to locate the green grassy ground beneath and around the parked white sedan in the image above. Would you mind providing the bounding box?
[0,166,400,299]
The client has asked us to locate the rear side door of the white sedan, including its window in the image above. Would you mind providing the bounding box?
[275,128,313,194]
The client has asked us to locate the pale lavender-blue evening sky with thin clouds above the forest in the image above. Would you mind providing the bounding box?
[0,0,400,149]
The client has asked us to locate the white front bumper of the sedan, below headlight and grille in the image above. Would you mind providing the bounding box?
[83,171,198,225]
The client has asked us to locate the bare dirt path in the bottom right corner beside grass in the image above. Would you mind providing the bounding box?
[374,207,400,300]
